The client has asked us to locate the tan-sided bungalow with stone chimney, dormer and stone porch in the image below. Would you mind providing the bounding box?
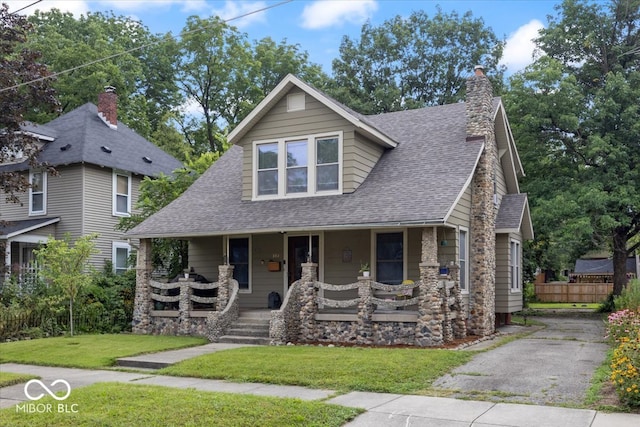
[128,67,533,345]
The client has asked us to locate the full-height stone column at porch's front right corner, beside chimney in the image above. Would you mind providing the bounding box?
[415,227,443,347]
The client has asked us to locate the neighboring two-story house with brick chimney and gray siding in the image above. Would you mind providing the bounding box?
[0,87,182,281]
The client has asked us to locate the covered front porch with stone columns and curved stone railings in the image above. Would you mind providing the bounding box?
[133,227,490,346]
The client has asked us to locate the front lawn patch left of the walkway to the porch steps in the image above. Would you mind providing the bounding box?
[0,334,207,368]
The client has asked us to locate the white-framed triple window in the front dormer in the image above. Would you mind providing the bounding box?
[252,131,344,200]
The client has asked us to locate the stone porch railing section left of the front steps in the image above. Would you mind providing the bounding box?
[133,258,239,341]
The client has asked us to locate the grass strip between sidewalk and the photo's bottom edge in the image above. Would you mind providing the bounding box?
[0,383,364,427]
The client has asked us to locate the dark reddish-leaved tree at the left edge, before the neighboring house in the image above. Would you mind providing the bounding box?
[0,4,58,204]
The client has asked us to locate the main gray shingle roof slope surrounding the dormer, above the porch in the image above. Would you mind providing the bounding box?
[128,103,482,237]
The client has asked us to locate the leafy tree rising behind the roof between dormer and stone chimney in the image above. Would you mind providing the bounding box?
[330,8,504,114]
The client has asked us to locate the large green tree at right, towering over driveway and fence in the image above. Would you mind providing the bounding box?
[507,0,640,294]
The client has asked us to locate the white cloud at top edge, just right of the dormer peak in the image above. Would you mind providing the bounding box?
[301,0,378,29]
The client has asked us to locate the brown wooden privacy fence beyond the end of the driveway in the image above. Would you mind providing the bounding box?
[535,282,613,303]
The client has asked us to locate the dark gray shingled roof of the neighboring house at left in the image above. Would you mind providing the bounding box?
[0,103,183,176]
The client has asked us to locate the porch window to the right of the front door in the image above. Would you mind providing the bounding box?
[376,233,404,285]
